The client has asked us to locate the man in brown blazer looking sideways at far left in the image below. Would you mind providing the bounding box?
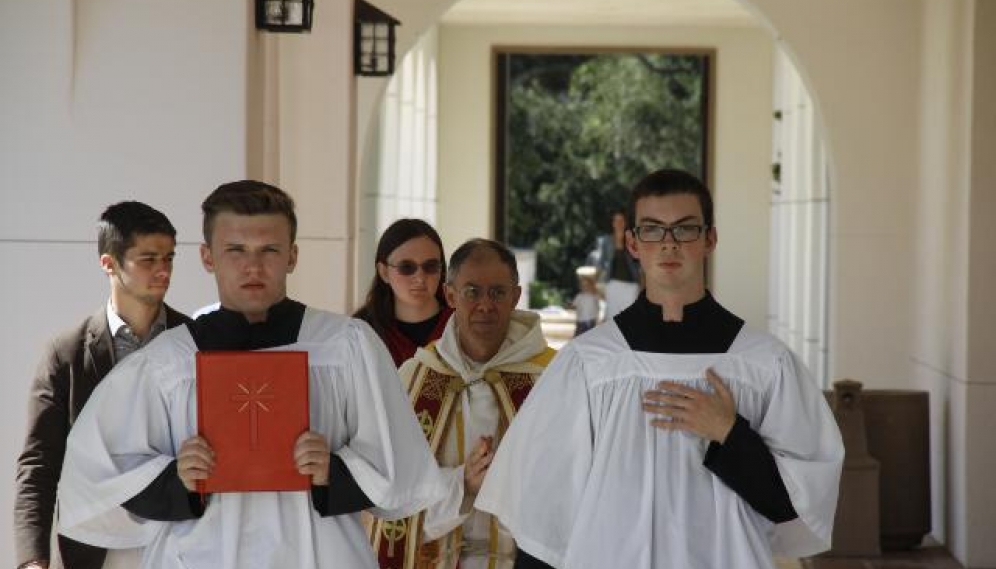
[14,201,189,569]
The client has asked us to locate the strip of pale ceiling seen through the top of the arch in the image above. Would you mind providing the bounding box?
[443,0,757,26]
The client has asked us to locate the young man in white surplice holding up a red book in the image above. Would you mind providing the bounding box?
[59,181,445,569]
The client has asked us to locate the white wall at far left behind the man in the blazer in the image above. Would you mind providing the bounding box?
[0,0,251,562]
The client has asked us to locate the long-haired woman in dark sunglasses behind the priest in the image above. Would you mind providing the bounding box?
[353,219,453,366]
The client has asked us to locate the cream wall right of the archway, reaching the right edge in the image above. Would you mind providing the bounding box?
[744,0,996,568]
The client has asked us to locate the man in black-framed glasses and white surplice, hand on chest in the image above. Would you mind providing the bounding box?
[476,170,844,569]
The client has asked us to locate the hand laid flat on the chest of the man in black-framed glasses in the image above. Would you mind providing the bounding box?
[643,369,737,444]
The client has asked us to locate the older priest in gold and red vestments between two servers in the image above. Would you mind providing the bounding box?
[372,239,555,569]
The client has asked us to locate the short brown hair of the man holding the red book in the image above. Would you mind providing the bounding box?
[201,180,297,245]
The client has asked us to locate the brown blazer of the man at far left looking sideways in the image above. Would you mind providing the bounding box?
[14,305,190,569]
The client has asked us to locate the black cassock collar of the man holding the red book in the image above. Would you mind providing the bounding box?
[187,298,305,351]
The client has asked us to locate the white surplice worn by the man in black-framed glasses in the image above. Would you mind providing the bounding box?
[475,320,844,569]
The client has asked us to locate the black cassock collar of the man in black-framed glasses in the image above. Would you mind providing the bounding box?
[615,290,744,354]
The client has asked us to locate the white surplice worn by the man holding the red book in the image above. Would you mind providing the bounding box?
[59,308,445,569]
